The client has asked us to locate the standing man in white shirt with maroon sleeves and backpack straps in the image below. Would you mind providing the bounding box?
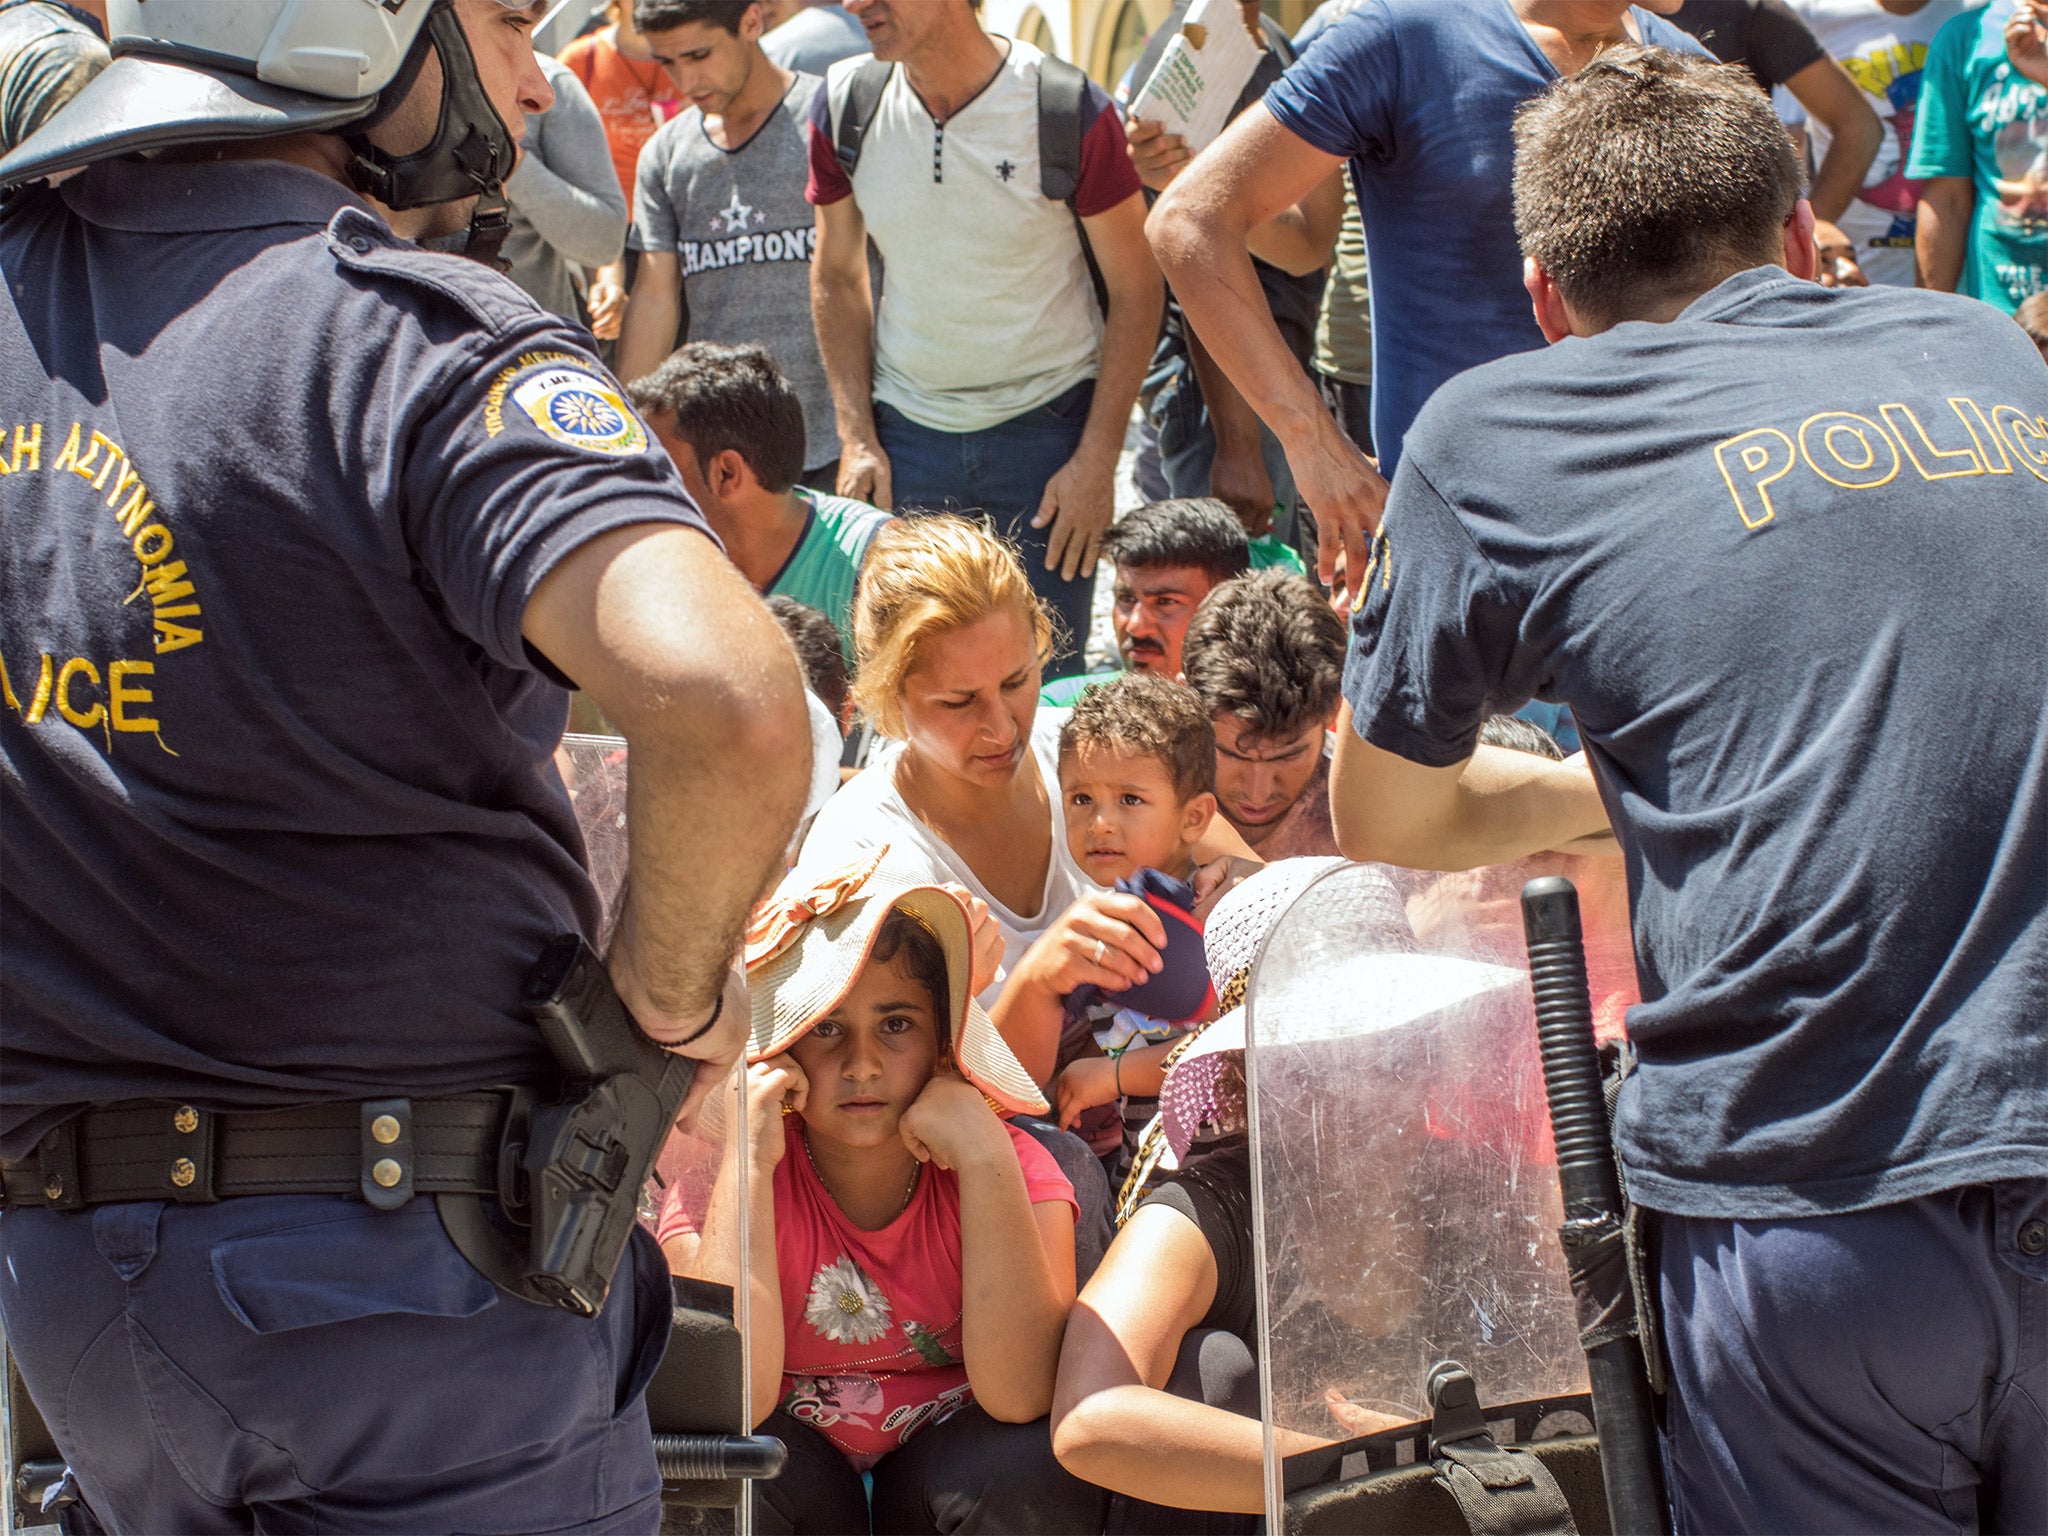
[809,0,1163,649]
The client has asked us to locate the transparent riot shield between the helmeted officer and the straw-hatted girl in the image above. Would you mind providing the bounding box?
[555,735,774,1536]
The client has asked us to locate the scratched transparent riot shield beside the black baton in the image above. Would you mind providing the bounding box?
[1245,856,1634,1532]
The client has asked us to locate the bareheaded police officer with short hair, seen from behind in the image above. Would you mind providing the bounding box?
[1331,47,2048,1532]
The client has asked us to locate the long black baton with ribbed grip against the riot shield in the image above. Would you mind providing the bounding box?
[1522,874,1671,1536]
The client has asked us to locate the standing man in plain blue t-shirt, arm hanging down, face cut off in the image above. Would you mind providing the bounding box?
[1147,0,1702,598]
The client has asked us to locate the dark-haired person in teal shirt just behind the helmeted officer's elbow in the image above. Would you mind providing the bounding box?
[627,342,893,668]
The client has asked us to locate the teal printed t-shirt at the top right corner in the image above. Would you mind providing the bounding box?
[1907,0,2048,313]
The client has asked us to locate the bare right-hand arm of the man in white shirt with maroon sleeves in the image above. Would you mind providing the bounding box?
[1032,193,1165,580]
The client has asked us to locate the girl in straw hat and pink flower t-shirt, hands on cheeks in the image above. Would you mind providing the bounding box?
[662,850,1090,1532]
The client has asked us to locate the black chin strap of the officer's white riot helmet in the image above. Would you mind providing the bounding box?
[346,0,518,270]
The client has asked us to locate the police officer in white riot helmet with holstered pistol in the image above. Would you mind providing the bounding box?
[0,0,811,1532]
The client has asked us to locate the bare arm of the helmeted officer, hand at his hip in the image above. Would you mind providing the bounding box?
[520,524,811,1061]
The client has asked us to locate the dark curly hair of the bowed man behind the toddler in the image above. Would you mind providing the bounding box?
[1180,569,1346,741]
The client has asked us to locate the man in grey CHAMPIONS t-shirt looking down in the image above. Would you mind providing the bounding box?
[618,0,840,479]
